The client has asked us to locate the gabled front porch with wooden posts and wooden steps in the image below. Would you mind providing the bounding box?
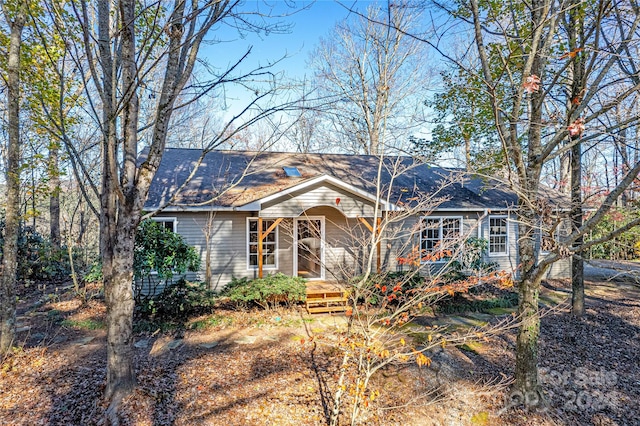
[246,175,392,313]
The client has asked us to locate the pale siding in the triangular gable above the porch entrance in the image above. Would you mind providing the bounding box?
[260,183,374,218]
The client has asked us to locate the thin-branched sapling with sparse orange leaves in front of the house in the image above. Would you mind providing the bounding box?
[291,156,517,425]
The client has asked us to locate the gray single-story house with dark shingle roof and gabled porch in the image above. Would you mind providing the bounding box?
[141,148,570,289]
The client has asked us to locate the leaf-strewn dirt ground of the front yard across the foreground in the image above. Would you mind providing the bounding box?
[0,263,640,425]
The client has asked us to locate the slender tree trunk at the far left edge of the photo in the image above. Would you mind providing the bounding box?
[0,2,26,354]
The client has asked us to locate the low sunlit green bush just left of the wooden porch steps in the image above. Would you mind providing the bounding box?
[222,273,306,309]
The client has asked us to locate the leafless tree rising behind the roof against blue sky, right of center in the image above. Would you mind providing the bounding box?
[311,2,428,154]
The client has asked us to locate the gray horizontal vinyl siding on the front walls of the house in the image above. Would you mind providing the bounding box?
[139,206,570,291]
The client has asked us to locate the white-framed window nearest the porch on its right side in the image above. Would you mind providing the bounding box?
[420,217,462,261]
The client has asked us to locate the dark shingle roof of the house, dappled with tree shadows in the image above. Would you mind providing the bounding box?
[140,148,517,210]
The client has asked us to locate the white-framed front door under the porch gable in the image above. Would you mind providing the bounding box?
[294,217,324,280]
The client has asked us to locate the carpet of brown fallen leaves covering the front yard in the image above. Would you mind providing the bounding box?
[0,268,640,426]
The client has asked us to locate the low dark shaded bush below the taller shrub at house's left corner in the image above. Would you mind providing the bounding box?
[137,278,217,321]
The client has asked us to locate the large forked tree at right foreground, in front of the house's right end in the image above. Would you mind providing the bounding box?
[438,0,640,406]
